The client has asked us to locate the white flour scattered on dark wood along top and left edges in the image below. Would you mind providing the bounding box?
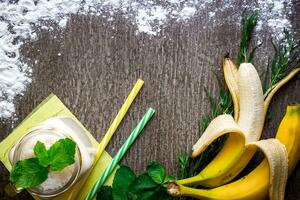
[0,0,292,118]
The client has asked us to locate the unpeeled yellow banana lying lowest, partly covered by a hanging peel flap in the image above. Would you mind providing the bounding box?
[168,105,300,200]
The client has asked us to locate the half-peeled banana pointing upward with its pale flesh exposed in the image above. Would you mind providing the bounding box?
[169,58,300,199]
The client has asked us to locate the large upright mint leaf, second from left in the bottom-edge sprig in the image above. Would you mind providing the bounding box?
[112,165,136,200]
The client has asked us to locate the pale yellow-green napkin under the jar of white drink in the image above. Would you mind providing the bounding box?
[0,94,114,200]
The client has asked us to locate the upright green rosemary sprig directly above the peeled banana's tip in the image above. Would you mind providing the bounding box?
[237,13,261,65]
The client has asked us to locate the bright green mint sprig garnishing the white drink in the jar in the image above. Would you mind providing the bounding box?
[10,138,76,188]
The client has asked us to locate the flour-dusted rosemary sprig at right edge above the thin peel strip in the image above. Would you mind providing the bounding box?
[263,29,300,97]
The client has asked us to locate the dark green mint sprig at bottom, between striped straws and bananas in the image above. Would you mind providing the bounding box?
[97,162,175,200]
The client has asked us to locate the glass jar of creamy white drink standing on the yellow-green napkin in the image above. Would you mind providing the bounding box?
[9,117,96,199]
